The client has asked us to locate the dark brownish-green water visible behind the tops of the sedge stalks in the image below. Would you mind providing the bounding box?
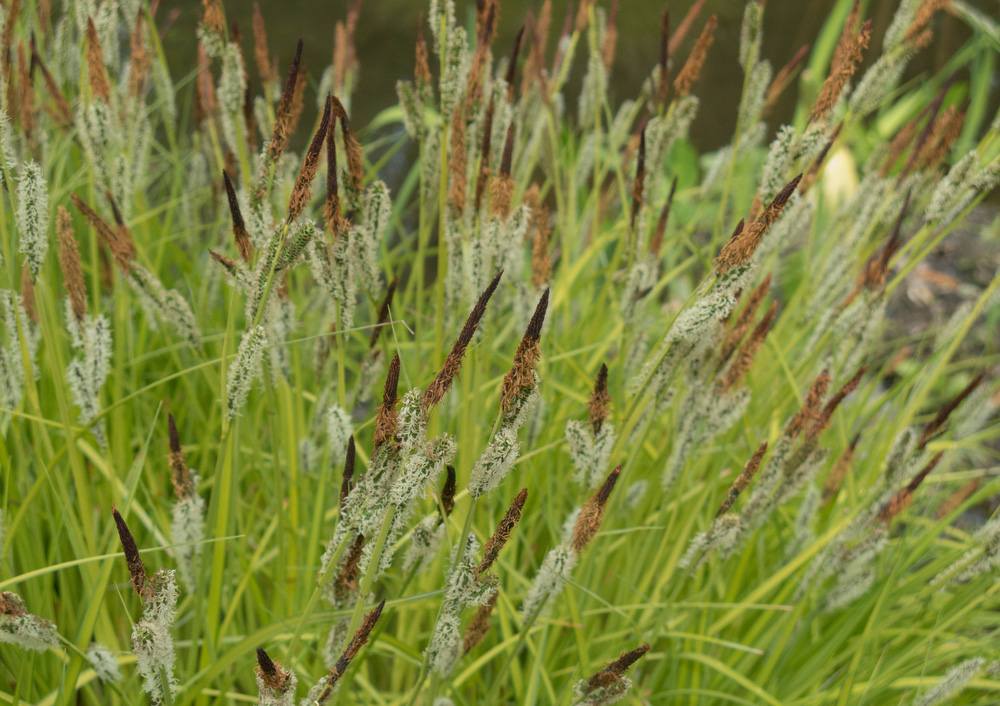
[158,0,1000,151]
